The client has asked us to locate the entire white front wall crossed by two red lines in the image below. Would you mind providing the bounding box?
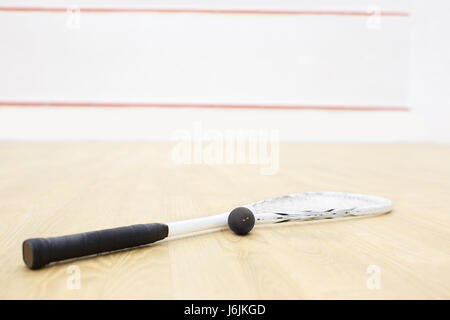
[0,0,448,141]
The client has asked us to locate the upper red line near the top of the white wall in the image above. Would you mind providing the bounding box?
[0,7,409,17]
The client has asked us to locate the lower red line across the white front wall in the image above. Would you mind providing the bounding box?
[0,101,410,112]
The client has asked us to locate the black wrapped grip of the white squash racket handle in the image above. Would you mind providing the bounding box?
[22,223,169,269]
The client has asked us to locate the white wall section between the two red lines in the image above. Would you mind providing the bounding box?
[0,0,409,107]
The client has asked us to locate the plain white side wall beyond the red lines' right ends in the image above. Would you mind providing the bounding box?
[410,0,450,142]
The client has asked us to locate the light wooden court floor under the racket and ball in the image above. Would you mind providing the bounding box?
[0,142,450,299]
